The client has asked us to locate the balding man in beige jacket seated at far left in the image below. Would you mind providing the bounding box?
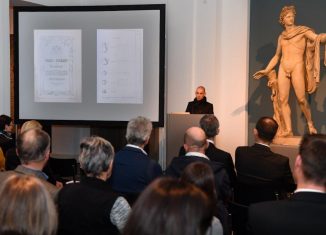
[0,129,59,199]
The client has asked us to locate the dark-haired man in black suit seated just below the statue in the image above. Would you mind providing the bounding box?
[234,117,295,205]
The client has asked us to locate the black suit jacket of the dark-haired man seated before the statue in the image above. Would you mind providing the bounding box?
[235,144,295,205]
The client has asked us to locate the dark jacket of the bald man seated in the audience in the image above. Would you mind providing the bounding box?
[166,156,232,201]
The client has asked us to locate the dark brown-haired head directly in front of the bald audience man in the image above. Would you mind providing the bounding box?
[181,162,217,204]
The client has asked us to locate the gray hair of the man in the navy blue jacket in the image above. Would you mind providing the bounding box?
[126,116,153,146]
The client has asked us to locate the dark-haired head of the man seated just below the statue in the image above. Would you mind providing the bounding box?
[256,117,278,142]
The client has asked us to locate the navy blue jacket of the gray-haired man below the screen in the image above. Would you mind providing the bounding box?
[109,146,162,193]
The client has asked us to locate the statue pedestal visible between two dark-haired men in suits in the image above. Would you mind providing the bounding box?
[270,136,302,173]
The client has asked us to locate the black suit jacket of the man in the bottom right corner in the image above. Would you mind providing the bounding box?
[248,192,326,235]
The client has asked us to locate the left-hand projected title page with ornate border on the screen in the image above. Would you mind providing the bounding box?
[34,29,82,103]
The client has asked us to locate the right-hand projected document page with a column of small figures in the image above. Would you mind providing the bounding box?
[97,29,143,104]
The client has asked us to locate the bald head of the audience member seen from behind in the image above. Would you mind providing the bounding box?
[184,127,206,153]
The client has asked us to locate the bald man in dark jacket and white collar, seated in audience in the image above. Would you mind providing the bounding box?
[166,127,232,202]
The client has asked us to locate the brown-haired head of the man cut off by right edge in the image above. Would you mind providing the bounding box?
[299,134,326,187]
